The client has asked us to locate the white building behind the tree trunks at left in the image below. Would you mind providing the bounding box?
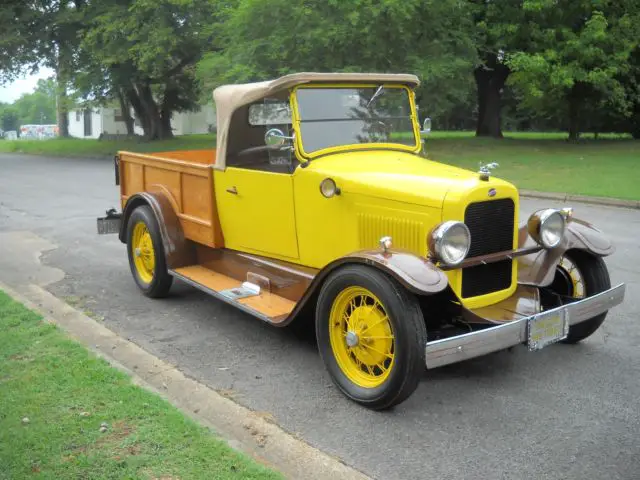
[69,105,216,138]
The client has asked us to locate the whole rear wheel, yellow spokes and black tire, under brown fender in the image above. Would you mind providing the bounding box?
[127,205,173,298]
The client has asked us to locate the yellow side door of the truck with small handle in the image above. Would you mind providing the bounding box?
[213,167,298,261]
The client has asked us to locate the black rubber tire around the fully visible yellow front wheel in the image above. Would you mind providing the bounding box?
[316,265,427,410]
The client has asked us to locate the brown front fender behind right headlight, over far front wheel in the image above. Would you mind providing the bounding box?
[518,218,615,287]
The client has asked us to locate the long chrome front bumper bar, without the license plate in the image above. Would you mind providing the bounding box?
[425,283,625,368]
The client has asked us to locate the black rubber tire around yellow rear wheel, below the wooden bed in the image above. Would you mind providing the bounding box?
[127,205,173,298]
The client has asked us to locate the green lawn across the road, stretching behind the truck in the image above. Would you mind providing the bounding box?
[0,132,640,200]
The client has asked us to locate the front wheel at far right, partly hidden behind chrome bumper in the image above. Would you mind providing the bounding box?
[550,250,611,343]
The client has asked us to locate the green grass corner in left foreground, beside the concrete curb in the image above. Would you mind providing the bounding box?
[0,291,281,480]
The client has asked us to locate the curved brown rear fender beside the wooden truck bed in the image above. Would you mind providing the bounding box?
[119,191,196,269]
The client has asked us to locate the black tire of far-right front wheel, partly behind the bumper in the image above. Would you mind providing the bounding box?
[551,250,611,344]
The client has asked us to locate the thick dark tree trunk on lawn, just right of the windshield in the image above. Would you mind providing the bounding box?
[474,54,509,138]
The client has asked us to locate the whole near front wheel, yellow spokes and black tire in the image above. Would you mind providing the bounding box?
[316,265,427,410]
